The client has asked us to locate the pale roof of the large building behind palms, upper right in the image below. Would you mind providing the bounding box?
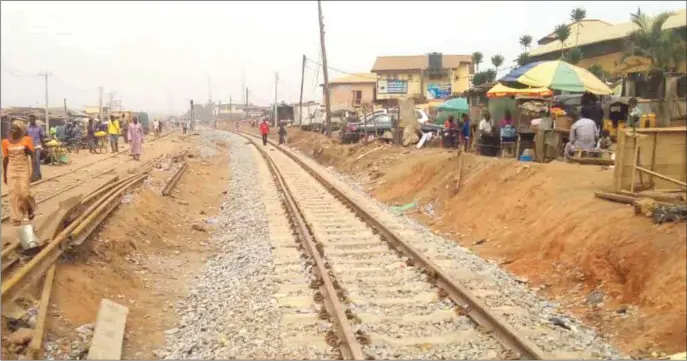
[530,9,687,56]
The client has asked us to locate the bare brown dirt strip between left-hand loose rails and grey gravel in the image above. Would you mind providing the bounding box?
[48,137,229,359]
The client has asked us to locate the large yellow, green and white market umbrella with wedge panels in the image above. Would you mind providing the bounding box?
[499,60,613,95]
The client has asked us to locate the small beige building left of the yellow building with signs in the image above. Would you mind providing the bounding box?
[322,73,377,111]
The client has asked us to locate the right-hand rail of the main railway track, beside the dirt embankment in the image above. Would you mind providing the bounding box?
[241,133,550,360]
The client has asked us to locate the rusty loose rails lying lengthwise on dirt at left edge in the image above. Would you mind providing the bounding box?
[1,171,148,307]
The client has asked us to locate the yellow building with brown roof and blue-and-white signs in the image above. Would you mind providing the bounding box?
[372,53,474,103]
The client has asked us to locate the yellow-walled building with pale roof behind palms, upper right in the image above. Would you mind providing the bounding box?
[529,9,687,75]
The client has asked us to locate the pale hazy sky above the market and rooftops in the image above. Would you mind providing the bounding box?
[0,1,685,113]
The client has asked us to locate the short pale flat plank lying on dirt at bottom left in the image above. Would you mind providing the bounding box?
[88,298,129,360]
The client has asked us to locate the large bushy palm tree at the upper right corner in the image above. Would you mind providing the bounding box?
[623,9,687,72]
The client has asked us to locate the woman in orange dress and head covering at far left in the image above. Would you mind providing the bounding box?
[2,120,36,226]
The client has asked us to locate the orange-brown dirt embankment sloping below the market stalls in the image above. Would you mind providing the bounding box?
[280,128,687,356]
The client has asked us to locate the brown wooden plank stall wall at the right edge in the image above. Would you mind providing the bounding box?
[614,127,687,191]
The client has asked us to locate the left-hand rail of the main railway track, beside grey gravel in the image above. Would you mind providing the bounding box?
[239,136,366,360]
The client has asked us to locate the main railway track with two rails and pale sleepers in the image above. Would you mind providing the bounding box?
[243,131,547,359]
